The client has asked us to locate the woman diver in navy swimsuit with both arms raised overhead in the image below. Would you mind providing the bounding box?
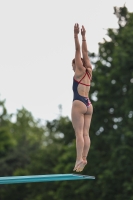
[71,24,93,172]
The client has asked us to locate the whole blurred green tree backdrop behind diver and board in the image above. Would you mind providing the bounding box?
[0,6,133,200]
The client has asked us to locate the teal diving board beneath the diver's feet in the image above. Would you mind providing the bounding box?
[0,174,95,184]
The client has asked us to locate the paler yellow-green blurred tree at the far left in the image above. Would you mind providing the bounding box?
[0,105,45,200]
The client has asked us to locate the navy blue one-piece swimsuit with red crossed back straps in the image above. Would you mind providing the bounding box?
[73,71,91,107]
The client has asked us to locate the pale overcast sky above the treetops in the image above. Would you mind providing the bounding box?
[0,0,133,121]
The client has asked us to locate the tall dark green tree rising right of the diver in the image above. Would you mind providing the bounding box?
[88,6,133,200]
